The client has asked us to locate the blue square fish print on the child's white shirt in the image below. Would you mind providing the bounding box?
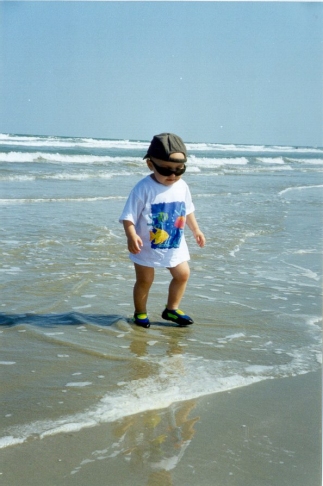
[149,201,186,249]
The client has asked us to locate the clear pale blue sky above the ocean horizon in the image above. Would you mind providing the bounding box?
[0,1,323,146]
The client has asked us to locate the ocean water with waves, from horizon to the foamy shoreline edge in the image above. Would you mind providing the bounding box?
[0,134,323,448]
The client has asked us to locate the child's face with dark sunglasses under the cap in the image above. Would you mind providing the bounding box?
[147,153,186,186]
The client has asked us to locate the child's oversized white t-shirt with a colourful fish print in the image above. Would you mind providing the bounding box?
[119,175,195,268]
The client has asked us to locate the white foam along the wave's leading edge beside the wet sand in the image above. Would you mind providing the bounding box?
[0,344,318,448]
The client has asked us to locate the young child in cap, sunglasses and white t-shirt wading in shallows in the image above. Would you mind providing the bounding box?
[119,133,205,327]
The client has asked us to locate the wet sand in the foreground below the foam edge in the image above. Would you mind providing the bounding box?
[0,372,321,486]
